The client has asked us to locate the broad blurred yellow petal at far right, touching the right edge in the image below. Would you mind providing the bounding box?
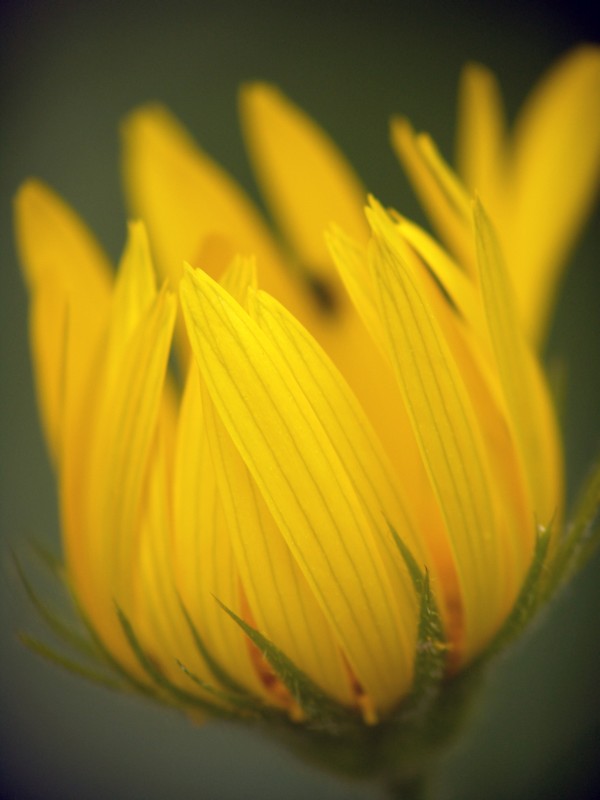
[502,45,600,342]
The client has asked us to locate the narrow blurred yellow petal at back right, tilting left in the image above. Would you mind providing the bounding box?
[391,118,475,273]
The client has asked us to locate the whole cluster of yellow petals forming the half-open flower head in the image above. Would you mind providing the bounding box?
[16,47,600,723]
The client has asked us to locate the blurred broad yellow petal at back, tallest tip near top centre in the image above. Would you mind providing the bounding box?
[240,83,368,274]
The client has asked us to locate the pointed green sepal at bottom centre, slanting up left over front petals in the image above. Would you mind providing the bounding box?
[217,600,358,727]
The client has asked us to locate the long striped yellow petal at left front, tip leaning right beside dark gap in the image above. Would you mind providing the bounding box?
[79,290,175,640]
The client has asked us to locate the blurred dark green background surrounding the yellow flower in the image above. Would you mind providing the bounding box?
[0,0,600,800]
